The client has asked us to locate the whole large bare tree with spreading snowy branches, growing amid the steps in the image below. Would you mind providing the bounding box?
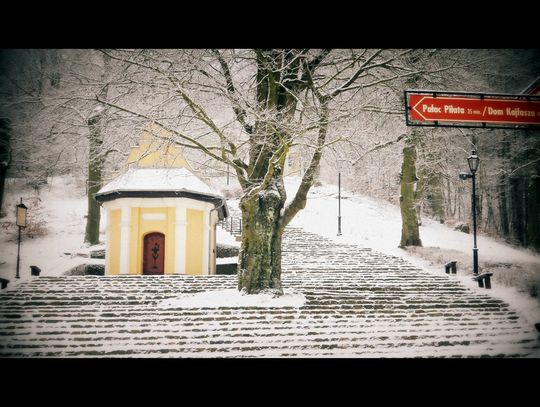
[90,49,458,294]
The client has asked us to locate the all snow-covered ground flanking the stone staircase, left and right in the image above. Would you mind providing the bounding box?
[0,177,540,328]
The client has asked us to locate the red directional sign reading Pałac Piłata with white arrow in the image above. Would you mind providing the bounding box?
[405,92,540,125]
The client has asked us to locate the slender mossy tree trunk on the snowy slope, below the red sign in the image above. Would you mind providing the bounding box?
[399,140,422,247]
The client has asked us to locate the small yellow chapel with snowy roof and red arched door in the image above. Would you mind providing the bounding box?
[95,124,228,275]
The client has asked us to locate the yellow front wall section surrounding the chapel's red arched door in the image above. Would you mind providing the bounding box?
[129,208,176,274]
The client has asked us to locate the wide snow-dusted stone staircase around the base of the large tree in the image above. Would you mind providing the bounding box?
[0,228,540,357]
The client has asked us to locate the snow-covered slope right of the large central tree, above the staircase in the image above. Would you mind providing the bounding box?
[285,178,540,323]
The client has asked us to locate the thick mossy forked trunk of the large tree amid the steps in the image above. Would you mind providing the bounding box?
[238,50,316,295]
